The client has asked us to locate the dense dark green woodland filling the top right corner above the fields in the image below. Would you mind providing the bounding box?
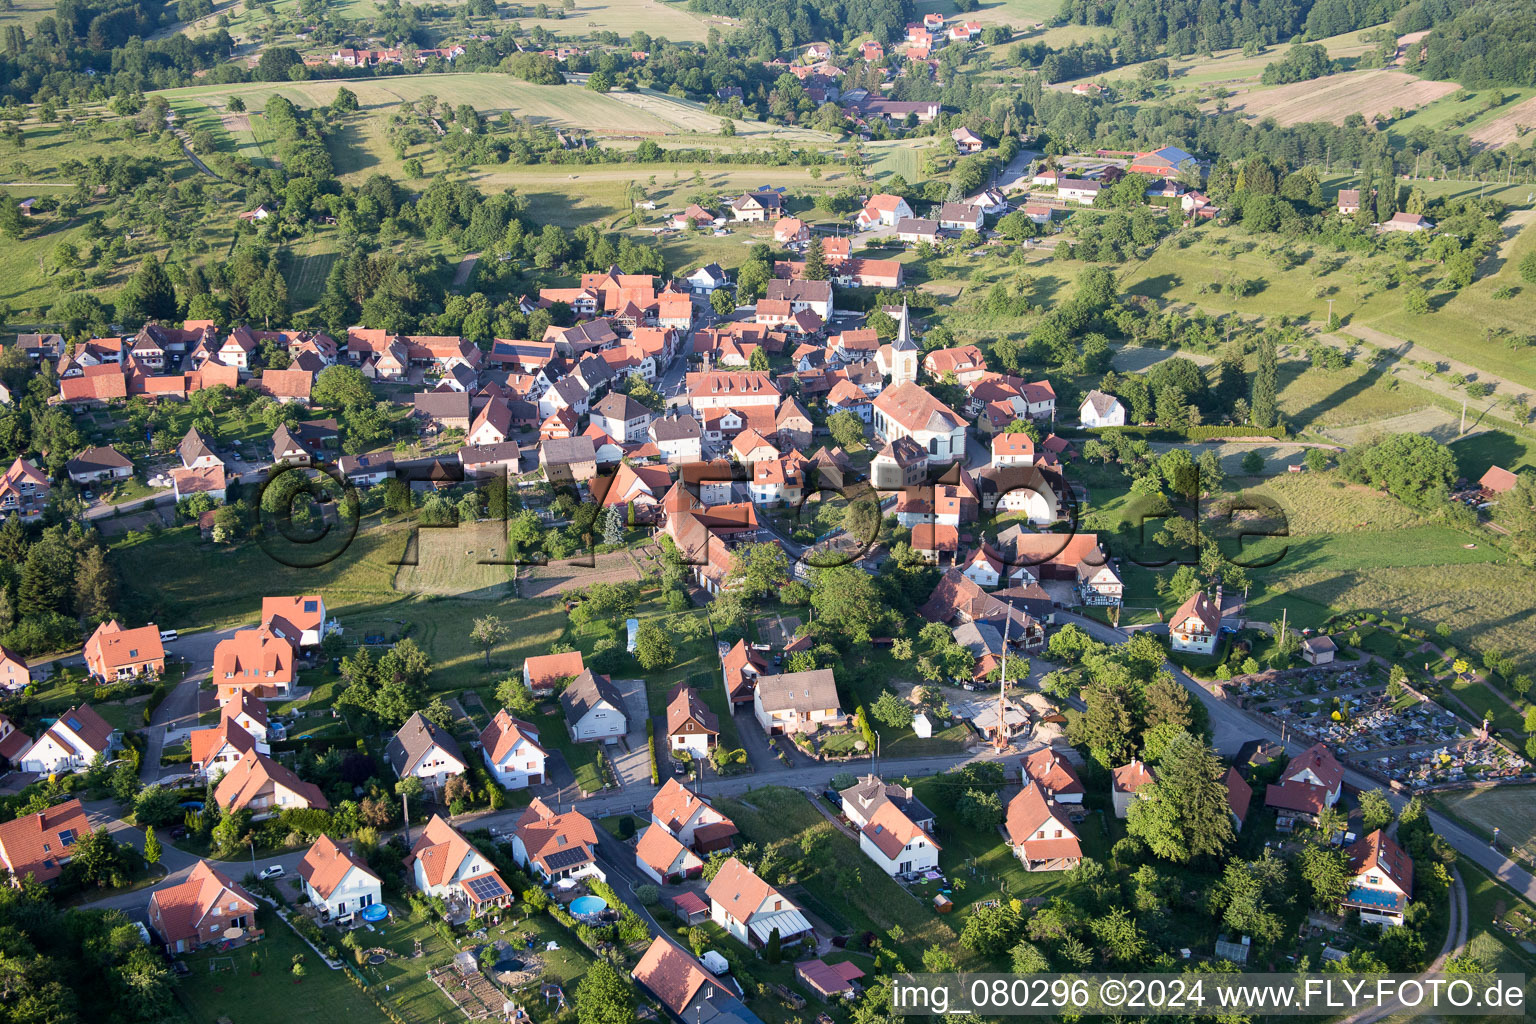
[1407,0,1536,86]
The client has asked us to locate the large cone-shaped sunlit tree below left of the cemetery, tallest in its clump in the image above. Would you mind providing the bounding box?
[1126,732,1232,863]
